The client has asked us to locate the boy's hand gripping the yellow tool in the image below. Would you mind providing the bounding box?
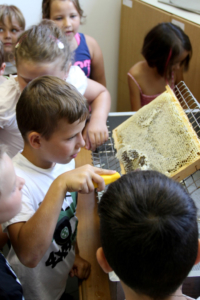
[59,165,115,194]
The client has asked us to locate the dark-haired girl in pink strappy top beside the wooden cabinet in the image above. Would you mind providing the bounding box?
[128,23,192,111]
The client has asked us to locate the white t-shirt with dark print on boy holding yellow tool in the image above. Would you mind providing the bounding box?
[2,153,78,300]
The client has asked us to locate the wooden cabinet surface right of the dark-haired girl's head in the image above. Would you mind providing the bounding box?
[171,15,200,102]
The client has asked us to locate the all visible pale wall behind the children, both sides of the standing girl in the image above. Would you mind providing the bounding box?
[0,0,121,111]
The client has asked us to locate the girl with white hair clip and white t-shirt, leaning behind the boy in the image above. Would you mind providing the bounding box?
[0,20,111,157]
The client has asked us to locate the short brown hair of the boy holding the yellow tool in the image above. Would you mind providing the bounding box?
[16,76,88,141]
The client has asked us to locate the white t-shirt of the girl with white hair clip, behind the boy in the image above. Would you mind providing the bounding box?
[0,66,87,157]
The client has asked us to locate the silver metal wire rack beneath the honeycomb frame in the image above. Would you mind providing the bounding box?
[92,81,200,202]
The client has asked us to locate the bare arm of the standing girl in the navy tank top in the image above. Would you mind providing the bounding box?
[85,35,106,86]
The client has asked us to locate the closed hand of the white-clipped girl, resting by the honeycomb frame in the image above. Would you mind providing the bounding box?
[83,119,108,151]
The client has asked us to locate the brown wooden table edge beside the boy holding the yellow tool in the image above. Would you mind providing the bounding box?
[76,149,111,300]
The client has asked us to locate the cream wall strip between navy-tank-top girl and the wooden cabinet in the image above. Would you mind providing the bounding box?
[79,0,121,111]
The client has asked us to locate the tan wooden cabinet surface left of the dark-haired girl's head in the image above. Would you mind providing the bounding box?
[117,0,171,111]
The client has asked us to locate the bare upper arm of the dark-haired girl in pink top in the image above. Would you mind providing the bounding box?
[128,72,141,111]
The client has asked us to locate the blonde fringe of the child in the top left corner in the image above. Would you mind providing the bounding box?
[0,5,26,30]
